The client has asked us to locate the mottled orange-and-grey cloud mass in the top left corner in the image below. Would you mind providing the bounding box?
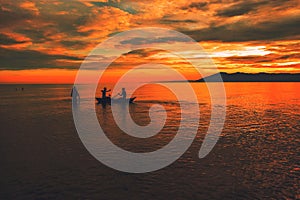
[0,1,96,43]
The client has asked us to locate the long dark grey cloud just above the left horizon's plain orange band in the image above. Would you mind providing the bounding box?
[0,48,82,70]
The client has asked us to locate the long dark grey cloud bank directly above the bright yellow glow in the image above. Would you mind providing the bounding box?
[179,16,300,42]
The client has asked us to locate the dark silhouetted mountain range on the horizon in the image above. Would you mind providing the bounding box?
[192,72,300,82]
